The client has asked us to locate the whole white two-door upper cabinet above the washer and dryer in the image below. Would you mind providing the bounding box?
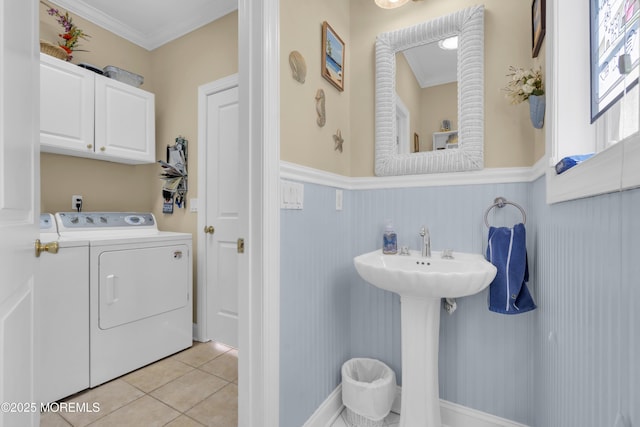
[40,54,155,164]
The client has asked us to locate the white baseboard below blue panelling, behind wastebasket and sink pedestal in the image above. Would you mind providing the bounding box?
[303,384,527,427]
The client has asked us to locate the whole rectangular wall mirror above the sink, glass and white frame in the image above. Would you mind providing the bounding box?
[375,6,484,176]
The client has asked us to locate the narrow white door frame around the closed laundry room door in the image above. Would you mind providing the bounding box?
[194,74,243,341]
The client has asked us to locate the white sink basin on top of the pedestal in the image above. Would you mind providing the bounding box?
[353,250,496,298]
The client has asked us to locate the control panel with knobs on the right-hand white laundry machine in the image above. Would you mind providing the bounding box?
[56,212,156,230]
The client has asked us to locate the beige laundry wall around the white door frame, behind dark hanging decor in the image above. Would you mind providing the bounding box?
[151,12,238,234]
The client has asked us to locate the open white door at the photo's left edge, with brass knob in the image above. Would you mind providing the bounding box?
[0,0,40,427]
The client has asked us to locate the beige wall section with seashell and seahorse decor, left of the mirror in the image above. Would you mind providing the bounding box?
[280,0,350,176]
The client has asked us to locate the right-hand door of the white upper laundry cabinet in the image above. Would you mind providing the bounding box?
[95,76,156,163]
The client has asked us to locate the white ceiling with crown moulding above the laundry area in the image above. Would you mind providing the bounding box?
[47,0,238,50]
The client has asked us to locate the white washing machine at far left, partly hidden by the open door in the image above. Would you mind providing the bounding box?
[35,214,89,402]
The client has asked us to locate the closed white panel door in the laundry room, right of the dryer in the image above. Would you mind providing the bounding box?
[198,75,240,348]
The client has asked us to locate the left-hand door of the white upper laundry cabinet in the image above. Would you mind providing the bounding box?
[40,53,94,154]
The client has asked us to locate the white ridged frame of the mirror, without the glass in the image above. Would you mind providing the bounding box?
[375,5,484,176]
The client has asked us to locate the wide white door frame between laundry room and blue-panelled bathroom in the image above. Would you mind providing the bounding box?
[238,0,280,427]
